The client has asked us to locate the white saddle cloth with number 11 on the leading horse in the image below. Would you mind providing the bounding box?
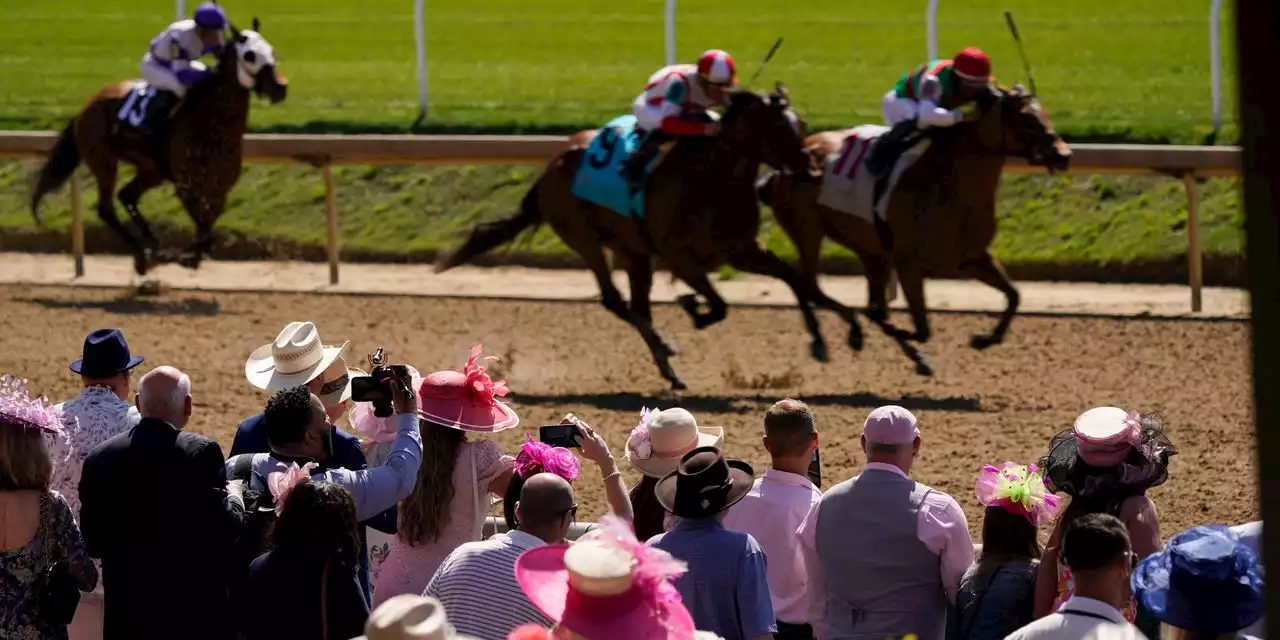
[818,124,929,223]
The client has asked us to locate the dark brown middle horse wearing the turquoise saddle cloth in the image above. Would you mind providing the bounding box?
[436,84,844,389]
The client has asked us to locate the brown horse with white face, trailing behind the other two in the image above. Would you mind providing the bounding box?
[31,18,288,275]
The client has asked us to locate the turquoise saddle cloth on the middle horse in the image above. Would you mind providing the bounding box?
[572,114,669,218]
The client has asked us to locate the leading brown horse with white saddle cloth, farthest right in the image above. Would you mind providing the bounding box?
[760,86,1071,375]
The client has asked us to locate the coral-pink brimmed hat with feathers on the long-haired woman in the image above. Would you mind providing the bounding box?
[417,344,520,434]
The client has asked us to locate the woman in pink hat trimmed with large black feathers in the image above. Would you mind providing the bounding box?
[1036,407,1178,622]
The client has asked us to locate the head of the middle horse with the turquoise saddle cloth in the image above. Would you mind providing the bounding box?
[721,82,812,175]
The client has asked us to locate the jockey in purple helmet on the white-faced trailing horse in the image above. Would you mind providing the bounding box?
[142,3,228,133]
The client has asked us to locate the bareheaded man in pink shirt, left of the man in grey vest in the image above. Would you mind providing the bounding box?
[724,398,822,640]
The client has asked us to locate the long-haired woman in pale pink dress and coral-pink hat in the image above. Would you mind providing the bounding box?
[372,344,520,607]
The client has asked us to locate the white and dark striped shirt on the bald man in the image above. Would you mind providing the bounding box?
[422,530,553,640]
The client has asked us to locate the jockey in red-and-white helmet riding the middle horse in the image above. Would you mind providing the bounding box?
[622,49,737,189]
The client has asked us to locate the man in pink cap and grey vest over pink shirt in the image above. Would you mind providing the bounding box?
[798,406,973,640]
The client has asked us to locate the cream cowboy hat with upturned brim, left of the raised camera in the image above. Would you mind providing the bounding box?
[244,321,351,393]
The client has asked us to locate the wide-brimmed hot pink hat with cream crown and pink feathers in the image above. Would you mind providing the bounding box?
[516,513,694,640]
